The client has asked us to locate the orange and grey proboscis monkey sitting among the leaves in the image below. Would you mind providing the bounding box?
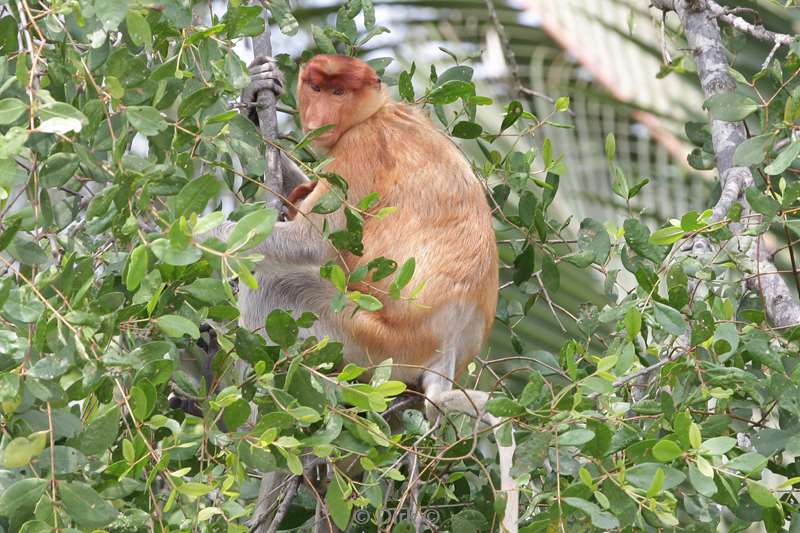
[231,55,518,533]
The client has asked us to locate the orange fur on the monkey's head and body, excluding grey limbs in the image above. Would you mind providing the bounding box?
[298,56,498,384]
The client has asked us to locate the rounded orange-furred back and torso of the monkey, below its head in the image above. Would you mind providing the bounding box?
[328,102,498,377]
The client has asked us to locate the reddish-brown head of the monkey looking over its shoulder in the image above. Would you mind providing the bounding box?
[297,55,387,149]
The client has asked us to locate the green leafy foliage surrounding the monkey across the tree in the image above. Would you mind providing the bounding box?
[0,0,800,532]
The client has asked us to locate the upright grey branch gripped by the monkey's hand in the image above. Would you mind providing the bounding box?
[253,2,283,212]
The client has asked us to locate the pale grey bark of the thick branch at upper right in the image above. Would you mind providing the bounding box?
[652,0,800,328]
